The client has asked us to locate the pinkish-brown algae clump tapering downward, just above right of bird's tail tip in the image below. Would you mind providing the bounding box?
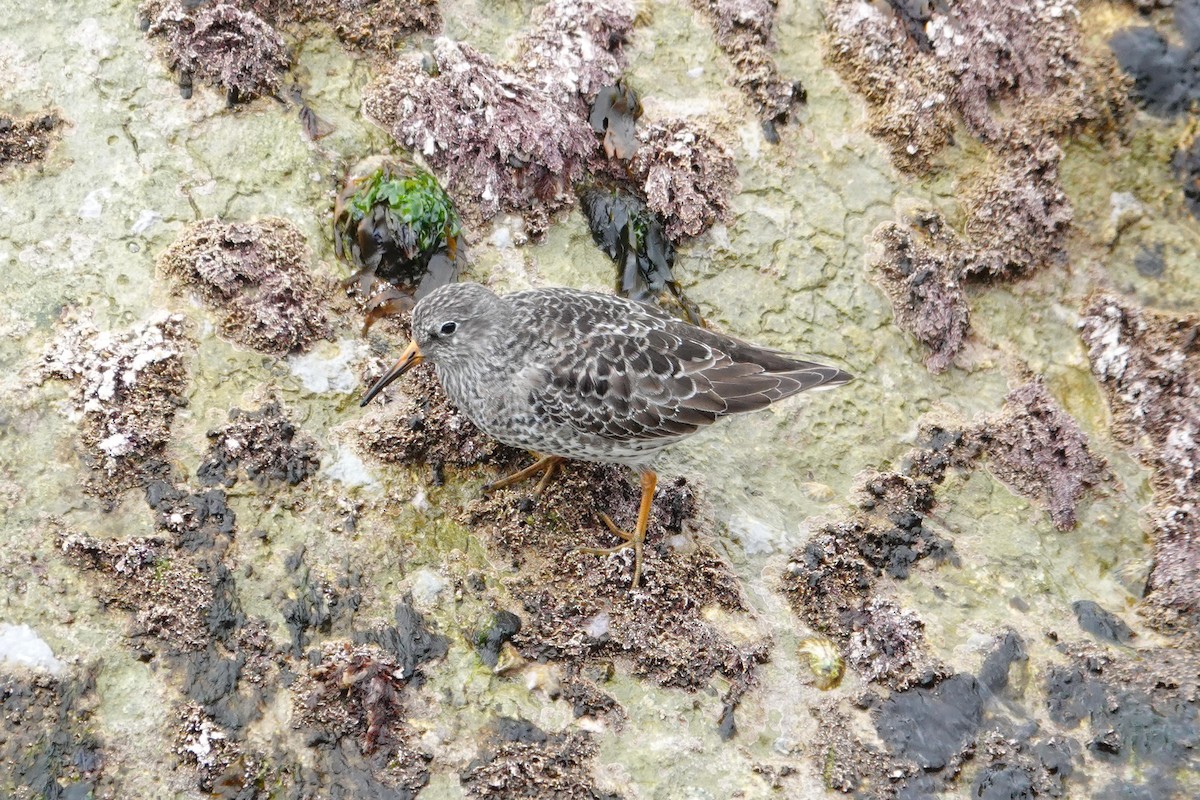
[871,212,974,373]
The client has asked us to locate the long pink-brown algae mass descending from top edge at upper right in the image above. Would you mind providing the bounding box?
[827,0,1127,359]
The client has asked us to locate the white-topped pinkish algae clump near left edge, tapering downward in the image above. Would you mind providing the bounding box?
[40,309,193,505]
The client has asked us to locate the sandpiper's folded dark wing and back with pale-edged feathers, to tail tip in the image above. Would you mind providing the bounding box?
[514,289,850,441]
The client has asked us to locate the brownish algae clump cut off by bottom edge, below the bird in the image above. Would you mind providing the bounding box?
[460,718,619,800]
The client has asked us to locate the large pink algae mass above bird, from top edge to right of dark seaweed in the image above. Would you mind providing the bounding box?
[364,0,737,241]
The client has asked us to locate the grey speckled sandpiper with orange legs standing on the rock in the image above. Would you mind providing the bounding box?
[361,283,851,589]
